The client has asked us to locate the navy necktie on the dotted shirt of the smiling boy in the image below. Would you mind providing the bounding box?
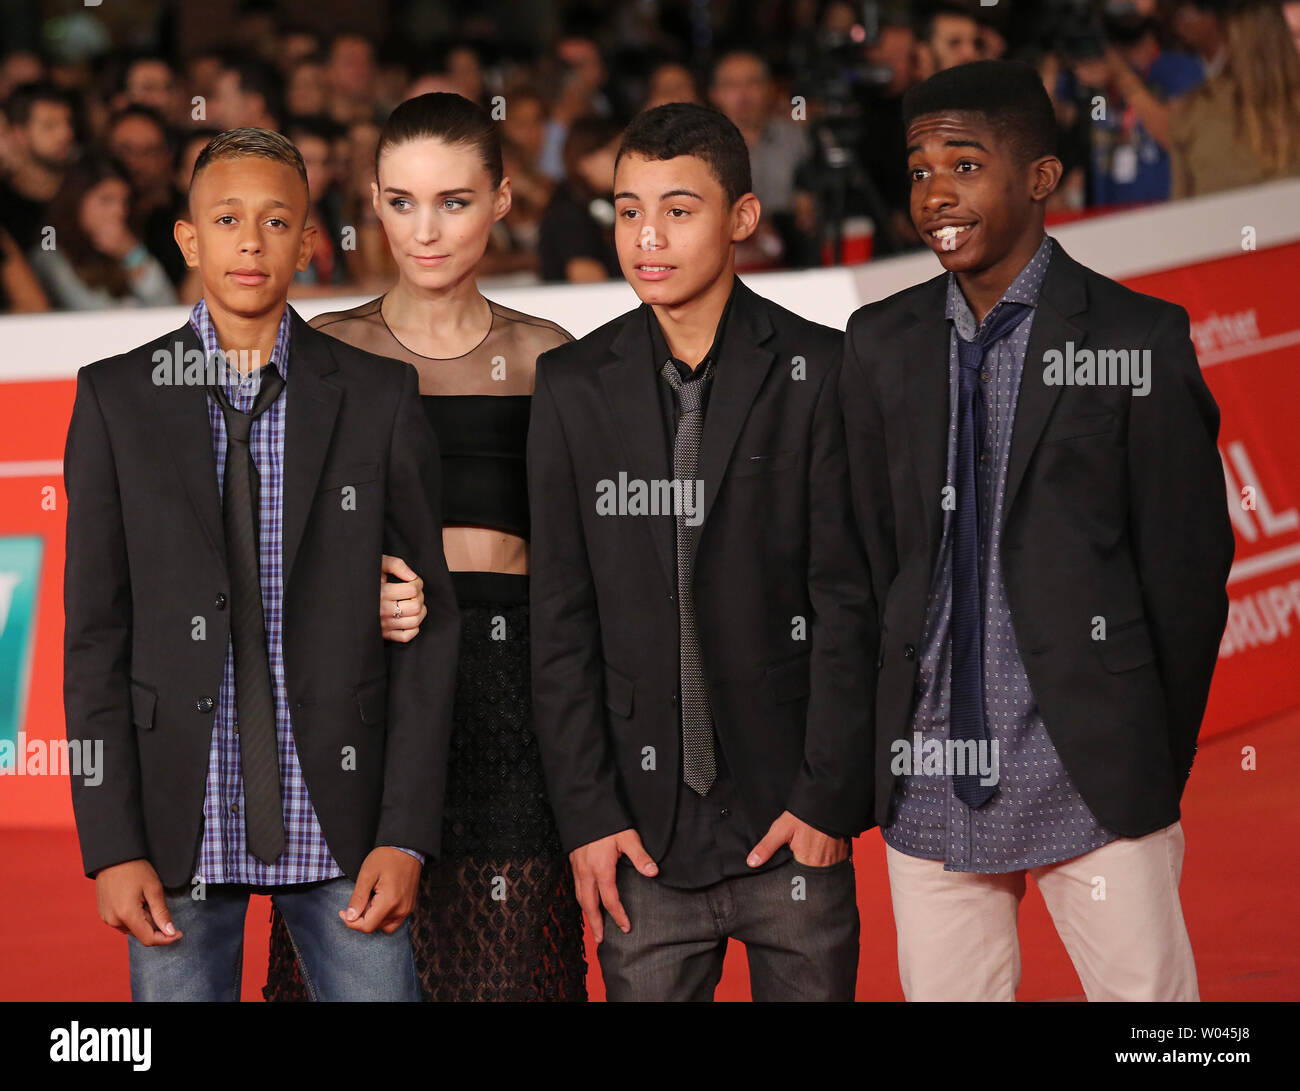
[949,303,1031,808]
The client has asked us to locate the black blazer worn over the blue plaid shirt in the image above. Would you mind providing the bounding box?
[64,305,459,886]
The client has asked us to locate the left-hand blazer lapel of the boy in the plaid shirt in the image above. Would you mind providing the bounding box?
[151,322,226,567]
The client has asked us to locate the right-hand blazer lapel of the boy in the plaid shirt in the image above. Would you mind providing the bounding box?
[282,308,342,588]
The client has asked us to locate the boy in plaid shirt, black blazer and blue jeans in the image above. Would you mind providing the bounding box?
[64,129,459,1000]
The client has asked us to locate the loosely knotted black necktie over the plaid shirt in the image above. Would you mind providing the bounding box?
[208,364,285,863]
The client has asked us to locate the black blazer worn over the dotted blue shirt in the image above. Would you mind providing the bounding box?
[840,243,1234,837]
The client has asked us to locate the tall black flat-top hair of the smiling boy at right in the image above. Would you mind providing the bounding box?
[902,61,1057,165]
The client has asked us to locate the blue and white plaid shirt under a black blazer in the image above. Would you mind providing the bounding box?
[190,299,424,887]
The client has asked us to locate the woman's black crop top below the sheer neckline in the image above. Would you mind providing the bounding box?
[420,394,532,538]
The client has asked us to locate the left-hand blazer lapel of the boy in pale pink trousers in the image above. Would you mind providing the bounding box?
[901,273,952,571]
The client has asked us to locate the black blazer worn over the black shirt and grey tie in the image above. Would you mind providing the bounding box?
[528,276,876,856]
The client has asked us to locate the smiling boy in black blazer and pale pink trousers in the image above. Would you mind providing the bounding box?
[841,61,1232,1000]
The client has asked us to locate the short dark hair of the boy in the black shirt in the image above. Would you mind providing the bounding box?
[614,103,754,208]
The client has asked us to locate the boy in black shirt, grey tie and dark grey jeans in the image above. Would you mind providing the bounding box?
[528,103,876,1000]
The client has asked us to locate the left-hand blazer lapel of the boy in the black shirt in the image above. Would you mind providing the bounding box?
[598,303,676,586]
